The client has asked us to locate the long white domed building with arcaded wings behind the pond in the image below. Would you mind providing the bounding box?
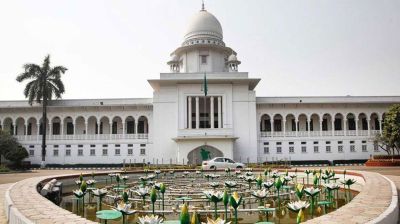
[0,6,400,164]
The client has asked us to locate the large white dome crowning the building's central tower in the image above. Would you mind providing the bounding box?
[185,10,222,40]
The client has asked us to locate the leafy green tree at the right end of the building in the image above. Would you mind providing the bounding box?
[375,104,400,155]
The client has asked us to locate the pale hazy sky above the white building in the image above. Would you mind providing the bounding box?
[0,0,400,100]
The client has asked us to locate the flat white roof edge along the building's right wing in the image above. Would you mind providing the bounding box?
[256,96,400,104]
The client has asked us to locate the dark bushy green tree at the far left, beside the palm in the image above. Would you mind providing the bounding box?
[0,131,29,166]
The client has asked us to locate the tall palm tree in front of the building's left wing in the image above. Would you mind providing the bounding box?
[17,55,67,167]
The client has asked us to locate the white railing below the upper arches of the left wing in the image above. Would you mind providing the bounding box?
[15,133,149,141]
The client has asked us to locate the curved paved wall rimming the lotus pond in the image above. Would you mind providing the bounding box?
[3,171,398,224]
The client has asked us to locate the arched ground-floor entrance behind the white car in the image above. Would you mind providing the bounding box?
[187,145,224,165]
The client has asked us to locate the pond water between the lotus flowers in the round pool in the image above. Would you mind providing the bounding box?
[60,171,358,224]
